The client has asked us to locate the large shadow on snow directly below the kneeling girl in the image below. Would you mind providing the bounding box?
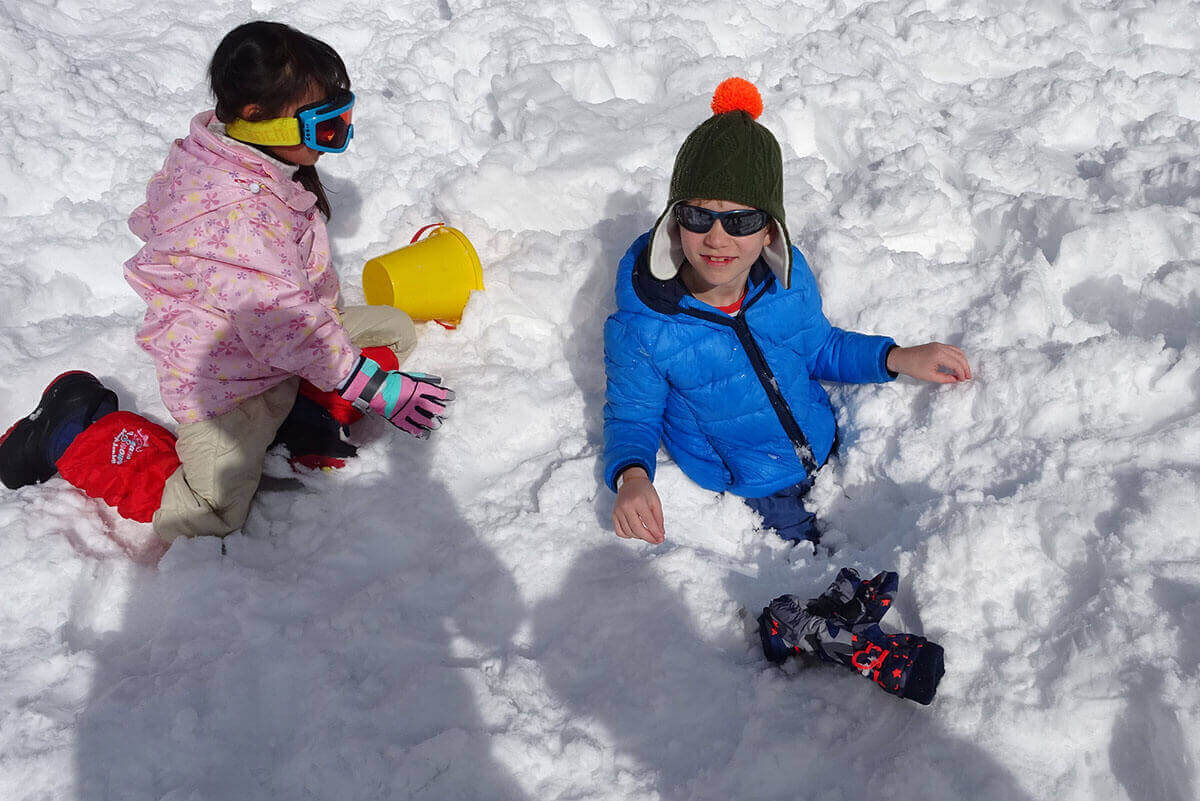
[65,421,524,801]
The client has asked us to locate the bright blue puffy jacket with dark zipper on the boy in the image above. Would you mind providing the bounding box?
[604,227,895,498]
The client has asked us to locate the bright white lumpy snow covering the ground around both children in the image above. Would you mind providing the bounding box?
[0,0,1200,801]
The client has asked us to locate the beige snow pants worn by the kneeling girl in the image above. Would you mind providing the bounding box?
[154,306,416,542]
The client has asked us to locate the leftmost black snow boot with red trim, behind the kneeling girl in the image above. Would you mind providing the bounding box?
[0,371,116,489]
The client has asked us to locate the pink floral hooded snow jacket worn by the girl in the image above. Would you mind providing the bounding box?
[125,112,358,422]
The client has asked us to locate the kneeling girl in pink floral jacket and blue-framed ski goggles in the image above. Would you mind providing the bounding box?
[0,22,454,542]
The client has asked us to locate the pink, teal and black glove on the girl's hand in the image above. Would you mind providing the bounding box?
[338,356,454,439]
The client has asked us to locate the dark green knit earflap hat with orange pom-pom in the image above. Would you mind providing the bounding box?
[649,78,792,289]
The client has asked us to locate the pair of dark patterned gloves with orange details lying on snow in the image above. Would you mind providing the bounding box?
[758,567,946,704]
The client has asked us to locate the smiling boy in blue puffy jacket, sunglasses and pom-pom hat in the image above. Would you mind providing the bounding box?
[604,78,971,544]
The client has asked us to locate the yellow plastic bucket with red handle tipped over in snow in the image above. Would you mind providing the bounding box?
[362,223,484,324]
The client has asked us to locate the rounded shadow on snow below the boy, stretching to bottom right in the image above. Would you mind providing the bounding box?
[534,543,1028,801]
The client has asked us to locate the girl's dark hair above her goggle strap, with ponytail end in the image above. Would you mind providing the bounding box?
[209,20,350,219]
